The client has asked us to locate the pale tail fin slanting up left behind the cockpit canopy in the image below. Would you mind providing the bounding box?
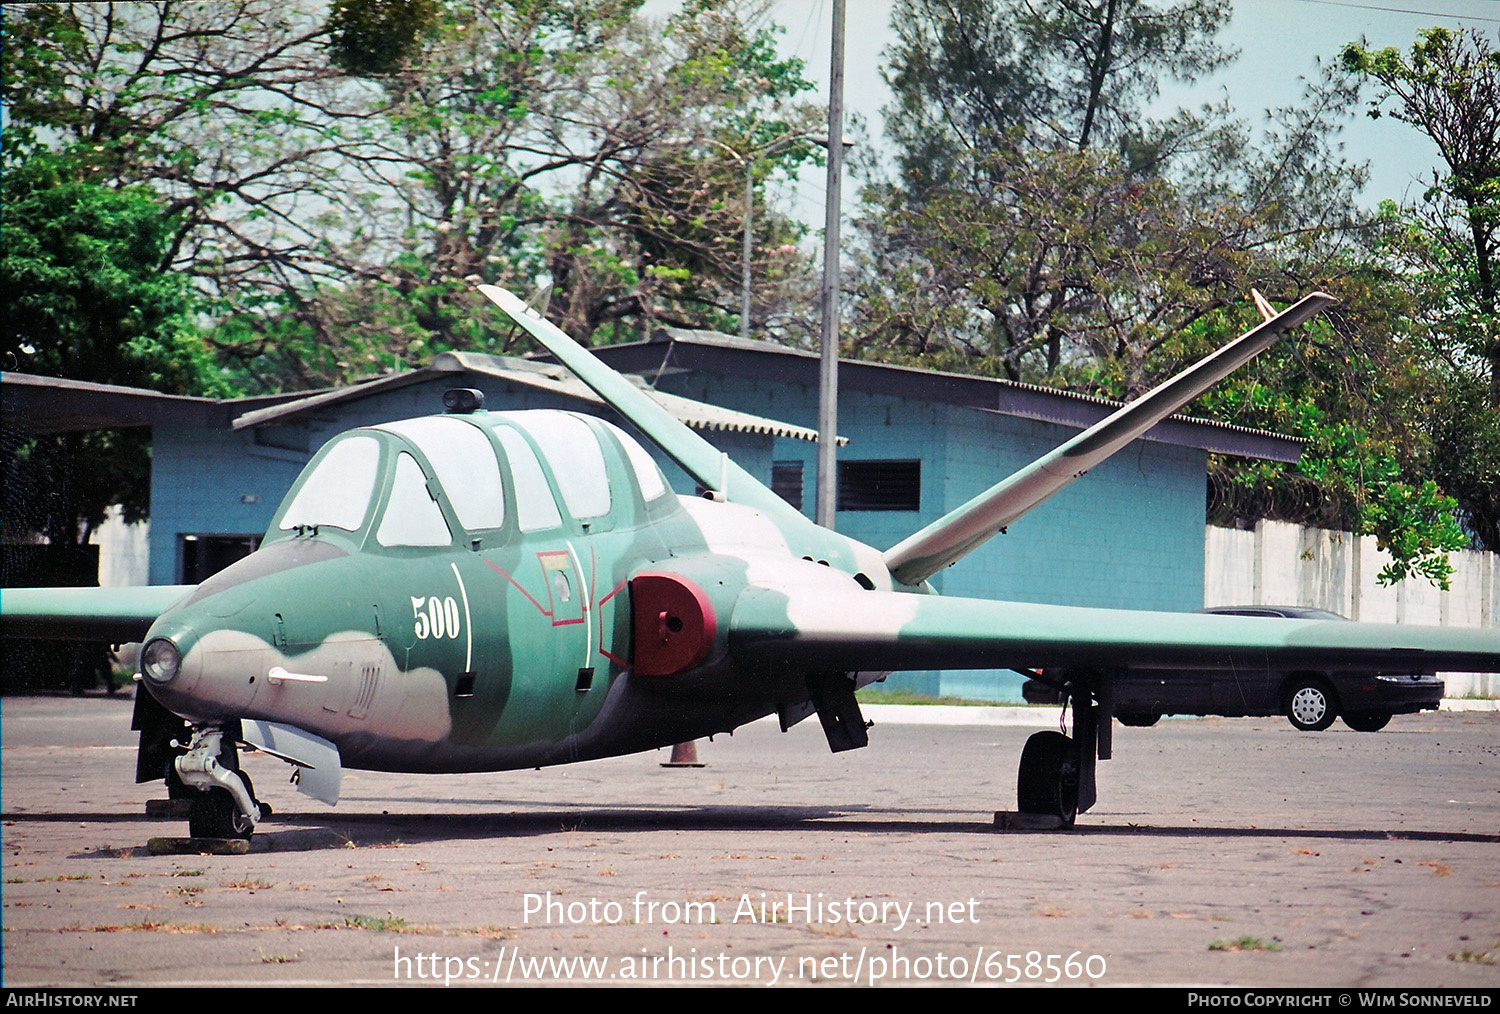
[479,285,812,525]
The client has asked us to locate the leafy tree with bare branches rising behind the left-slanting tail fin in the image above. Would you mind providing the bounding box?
[331,0,810,352]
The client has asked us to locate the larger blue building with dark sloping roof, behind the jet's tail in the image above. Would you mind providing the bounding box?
[596,329,1301,699]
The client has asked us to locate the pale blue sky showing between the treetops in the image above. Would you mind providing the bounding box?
[687,0,1500,228]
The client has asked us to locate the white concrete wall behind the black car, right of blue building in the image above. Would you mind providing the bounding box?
[1203,521,1500,698]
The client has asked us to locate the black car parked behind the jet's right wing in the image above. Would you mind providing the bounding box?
[1022,606,1443,732]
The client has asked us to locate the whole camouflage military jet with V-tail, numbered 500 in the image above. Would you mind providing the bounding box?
[0,287,1500,839]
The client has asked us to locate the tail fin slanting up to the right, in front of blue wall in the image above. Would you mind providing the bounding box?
[885,293,1335,585]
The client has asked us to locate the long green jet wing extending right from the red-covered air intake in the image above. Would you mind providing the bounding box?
[729,588,1500,674]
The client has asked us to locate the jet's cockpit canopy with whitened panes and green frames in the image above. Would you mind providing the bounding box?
[267,410,675,549]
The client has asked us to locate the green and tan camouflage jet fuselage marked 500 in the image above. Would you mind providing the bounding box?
[144,413,891,771]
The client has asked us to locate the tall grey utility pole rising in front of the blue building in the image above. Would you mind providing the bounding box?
[818,0,845,530]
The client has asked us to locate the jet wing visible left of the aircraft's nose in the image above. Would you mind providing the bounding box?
[0,585,194,644]
